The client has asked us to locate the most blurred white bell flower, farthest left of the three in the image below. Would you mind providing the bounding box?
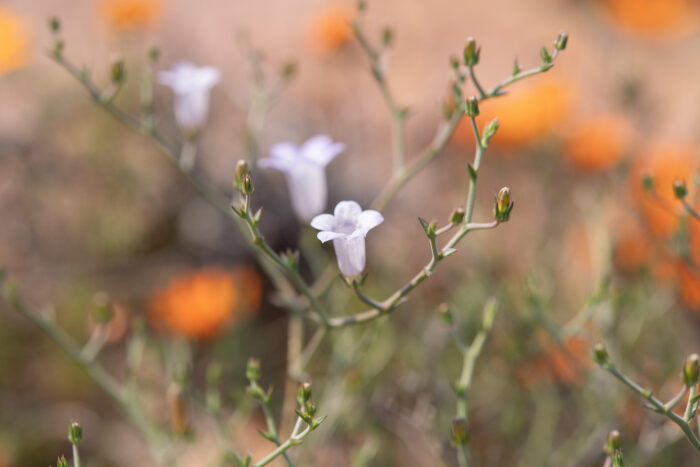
[158,62,220,131]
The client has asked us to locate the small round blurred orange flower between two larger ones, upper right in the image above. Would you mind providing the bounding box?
[563,113,632,172]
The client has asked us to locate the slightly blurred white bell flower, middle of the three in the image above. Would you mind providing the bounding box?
[258,135,345,221]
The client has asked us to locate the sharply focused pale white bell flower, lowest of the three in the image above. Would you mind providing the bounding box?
[311,201,384,277]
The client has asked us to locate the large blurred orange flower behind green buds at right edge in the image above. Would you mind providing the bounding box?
[630,144,698,238]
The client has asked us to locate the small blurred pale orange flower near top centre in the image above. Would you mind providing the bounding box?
[308,4,355,54]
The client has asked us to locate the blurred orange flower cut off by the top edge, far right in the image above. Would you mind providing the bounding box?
[603,0,700,37]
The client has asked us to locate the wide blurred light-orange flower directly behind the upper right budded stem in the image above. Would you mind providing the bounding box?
[454,78,574,148]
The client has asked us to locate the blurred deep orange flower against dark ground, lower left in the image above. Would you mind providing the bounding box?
[149,267,262,339]
